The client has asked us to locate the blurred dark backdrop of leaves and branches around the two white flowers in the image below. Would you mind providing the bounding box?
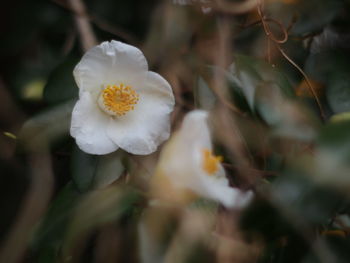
[0,0,350,263]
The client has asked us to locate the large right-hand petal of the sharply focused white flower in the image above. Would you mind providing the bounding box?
[107,72,174,155]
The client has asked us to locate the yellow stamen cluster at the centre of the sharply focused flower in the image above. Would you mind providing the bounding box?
[98,83,139,116]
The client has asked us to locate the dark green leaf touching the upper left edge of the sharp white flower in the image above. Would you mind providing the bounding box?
[44,57,78,104]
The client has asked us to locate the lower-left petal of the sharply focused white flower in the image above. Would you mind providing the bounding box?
[70,92,118,154]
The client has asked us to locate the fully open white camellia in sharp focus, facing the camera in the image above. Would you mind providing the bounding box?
[70,40,174,155]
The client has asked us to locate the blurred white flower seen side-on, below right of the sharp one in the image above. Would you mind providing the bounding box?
[152,110,253,208]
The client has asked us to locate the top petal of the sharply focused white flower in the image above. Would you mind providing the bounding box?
[73,40,148,93]
